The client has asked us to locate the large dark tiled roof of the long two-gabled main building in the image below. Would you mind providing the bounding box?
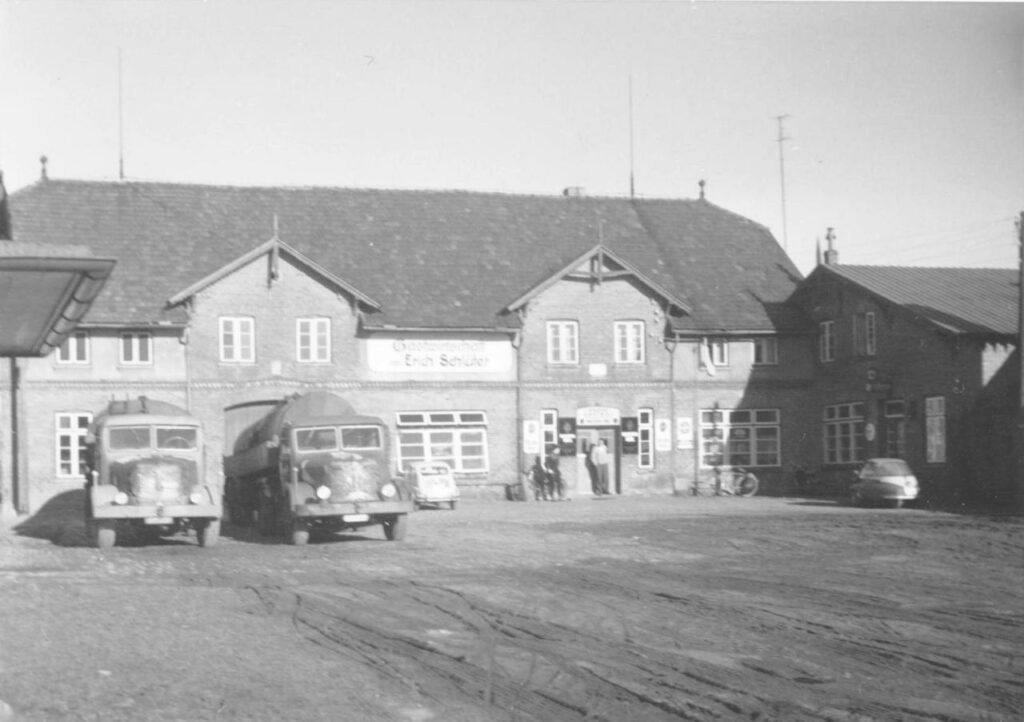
[11,180,801,331]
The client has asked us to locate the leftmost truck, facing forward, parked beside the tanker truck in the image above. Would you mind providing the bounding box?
[83,396,222,549]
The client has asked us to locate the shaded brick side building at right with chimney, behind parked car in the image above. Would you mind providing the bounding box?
[791,249,1020,502]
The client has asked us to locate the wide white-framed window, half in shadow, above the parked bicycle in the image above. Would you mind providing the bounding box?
[700,409,781,467]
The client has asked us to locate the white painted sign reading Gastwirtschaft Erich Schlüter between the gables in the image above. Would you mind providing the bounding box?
[367,338,513,374]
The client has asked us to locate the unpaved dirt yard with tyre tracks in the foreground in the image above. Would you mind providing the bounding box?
[0,497,1024,722]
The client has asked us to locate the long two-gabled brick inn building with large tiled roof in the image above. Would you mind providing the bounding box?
[0,178,815,511]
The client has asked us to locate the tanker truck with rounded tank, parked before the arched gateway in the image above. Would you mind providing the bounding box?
[224,391,413,544]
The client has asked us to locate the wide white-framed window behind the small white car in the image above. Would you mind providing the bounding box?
[398,411,488,474]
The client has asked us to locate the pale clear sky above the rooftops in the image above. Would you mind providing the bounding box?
[0,0,1024,273]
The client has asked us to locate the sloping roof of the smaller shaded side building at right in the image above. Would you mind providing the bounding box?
[808,265,1020,336]
